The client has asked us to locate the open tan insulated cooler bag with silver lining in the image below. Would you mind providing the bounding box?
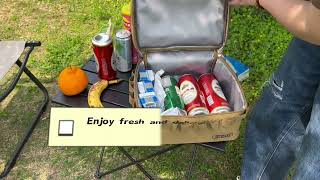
[130,0,247,144]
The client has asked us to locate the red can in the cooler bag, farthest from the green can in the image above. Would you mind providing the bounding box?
[198,73,231,113]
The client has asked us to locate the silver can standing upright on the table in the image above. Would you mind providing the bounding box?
[115,29,132,72]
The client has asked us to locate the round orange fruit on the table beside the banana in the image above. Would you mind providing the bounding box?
[58,66,89,96]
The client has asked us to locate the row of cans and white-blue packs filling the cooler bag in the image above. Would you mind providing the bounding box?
[138,70,231,116]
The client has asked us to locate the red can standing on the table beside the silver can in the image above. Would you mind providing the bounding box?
[92,33,117,80]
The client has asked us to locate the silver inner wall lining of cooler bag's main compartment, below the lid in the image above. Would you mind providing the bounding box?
[138,51,246,112]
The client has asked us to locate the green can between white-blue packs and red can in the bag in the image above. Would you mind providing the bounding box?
[162,76,184,110]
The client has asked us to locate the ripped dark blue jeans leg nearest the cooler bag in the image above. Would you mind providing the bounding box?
[241,38,320,180]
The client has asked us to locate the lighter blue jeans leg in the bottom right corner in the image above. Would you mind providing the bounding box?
[294,86,320,180]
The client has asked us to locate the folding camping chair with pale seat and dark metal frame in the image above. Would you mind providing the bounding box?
[0,41,49,179]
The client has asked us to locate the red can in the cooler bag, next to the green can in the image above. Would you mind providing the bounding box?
[178,74,209,116]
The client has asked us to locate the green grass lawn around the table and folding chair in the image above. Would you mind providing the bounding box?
[0,0,291,179]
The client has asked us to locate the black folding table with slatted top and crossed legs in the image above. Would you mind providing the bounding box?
[52,57,225,179]
